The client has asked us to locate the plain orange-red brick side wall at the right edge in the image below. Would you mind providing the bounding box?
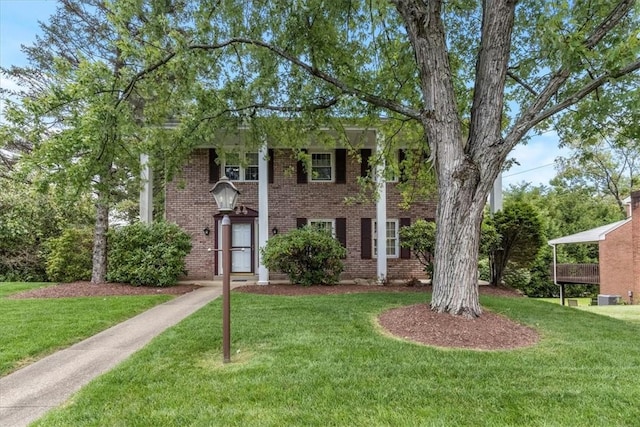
[599,222,635,302]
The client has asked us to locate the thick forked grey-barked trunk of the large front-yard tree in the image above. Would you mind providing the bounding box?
[393,0,515,317]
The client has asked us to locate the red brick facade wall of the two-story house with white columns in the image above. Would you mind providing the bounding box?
[165,149,435,279]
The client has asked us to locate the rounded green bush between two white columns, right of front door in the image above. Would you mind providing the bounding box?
[262,226,347,286]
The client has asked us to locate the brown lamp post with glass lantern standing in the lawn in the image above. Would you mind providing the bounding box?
[209,176,240,363]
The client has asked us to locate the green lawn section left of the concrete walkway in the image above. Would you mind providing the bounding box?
[0,282,172,376]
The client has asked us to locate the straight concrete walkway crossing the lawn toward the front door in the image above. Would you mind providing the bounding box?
[0,282,222,427]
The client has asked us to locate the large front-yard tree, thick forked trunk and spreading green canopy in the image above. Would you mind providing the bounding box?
[2,0,640,317]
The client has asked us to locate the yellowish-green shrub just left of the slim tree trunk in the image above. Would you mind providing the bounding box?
[47,228,93,282]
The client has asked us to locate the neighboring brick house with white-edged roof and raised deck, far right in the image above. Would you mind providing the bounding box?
[549,191,640,304]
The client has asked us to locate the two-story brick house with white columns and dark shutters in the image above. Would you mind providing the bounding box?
[165,128,435,284]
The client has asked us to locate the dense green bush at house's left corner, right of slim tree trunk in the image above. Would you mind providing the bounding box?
[107,222,191,286]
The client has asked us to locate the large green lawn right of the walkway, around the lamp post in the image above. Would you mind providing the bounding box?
[36,293,640,426]
